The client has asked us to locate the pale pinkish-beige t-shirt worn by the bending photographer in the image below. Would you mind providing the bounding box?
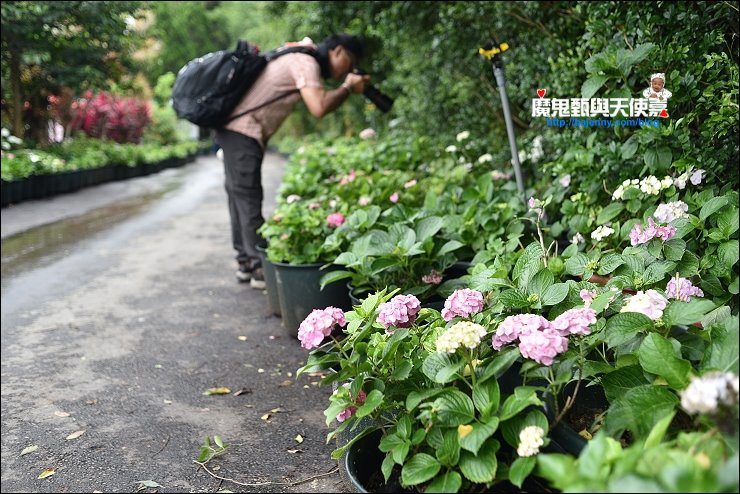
[224,53,323,149]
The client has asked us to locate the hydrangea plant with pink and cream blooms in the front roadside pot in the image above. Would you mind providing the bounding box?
[299,289,580,492]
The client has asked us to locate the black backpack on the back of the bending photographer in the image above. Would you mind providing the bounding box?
[172,40,316,129]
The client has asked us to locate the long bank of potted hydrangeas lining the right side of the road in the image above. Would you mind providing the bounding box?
[263,129,738,492]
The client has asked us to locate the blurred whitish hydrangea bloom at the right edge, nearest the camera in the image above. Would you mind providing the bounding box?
[681,372,739,414]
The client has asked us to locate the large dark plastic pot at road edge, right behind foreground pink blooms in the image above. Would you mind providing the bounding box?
[273,262,351,337]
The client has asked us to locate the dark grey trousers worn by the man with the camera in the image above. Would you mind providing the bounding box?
[216,129,265,267]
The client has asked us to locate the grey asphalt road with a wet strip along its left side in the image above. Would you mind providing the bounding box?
[1,153,349,492]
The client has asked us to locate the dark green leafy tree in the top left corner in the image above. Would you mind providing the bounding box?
[1,1,139,143]
